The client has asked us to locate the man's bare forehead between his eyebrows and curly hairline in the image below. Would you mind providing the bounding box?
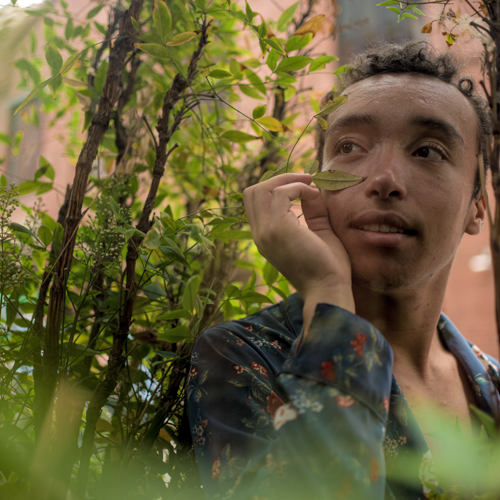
[329,73,479,142]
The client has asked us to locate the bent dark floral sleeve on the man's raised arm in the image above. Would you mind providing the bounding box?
[188,304,392,500]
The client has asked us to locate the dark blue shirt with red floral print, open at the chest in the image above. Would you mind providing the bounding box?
[188,294,499,500]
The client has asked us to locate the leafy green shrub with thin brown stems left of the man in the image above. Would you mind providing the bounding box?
[0,0,342,499]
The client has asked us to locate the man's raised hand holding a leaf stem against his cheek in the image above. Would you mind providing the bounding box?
[243,174,354,326]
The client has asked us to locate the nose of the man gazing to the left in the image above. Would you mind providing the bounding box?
[364,151,407,200]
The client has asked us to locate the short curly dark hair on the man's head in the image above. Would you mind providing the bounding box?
[316,41,492,197]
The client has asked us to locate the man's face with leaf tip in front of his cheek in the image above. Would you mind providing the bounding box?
[323,74,484,290]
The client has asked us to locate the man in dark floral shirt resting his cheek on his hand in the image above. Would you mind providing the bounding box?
[188,43,499,499]
